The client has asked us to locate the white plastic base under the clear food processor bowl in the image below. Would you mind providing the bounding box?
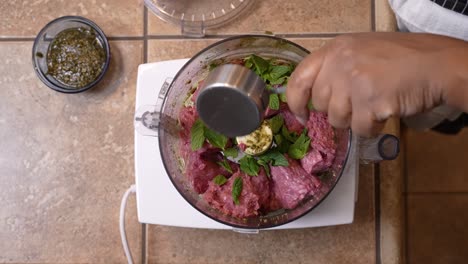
[135,59,359,229]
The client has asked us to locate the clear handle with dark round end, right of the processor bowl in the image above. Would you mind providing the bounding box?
[359,134,400,164]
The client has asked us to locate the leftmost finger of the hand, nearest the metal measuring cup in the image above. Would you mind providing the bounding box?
[286,48,325,120]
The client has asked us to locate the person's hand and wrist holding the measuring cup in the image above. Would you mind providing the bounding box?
[286,33,468,136]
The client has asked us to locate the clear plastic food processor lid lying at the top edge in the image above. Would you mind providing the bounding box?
[145,0,254,37]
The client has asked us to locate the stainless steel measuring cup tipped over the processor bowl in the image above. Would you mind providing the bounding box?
[196,64,284,137]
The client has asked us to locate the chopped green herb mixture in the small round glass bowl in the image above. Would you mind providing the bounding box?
[47,27,106,88]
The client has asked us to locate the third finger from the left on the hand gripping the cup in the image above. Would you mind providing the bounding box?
[328,86,352,128]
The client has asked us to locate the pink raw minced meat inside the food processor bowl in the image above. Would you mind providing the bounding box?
[179,55,336,218]
